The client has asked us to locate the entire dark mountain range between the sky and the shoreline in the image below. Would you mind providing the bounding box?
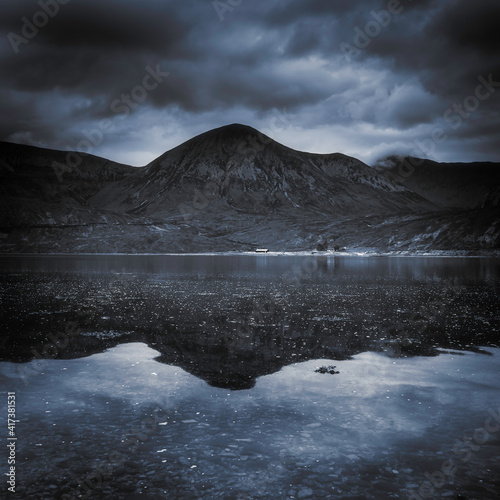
[0,124,500,254]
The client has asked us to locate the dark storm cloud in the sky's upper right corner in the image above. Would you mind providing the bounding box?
[344,0,500,98]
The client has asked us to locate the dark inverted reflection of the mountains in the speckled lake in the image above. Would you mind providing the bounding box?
[0,256,500,389]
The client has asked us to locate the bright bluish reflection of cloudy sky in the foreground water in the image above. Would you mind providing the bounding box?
[0,343,500,499]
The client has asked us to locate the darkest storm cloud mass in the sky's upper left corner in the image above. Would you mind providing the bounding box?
[0,0,194,95]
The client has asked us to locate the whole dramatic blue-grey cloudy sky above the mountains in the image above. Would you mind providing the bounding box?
[0,0,500,165]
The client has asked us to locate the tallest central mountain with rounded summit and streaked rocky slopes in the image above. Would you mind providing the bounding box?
[91,125,431,217]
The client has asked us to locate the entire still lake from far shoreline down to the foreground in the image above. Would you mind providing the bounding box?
[0,255,500,499]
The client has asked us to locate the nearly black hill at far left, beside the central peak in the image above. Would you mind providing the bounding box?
[0,142,134,228]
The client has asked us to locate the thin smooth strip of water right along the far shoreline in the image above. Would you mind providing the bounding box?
[0,254,500,283]
